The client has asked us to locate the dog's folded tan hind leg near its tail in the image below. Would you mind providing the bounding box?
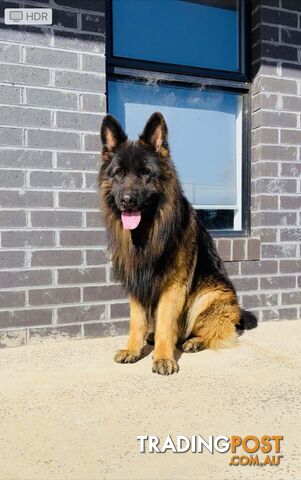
[182,289,240,352]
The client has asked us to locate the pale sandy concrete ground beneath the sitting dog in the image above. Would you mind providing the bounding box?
[0,321,301,480]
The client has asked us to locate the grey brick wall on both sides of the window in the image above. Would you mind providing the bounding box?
[0,0,301,346]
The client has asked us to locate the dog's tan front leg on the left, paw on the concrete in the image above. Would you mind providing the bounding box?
[114,298,147,363]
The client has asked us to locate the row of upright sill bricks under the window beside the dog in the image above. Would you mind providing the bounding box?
[214,237,260,262]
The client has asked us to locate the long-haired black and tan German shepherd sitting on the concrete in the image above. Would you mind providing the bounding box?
[99,113,257,375]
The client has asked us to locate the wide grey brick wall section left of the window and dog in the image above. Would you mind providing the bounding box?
[0,0,128,346]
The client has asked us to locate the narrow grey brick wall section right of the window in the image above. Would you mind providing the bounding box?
[246,0,301,320]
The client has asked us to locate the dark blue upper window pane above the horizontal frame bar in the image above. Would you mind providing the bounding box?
[112,0,239,71]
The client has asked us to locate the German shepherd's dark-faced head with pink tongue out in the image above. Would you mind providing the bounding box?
[99,113,173,230]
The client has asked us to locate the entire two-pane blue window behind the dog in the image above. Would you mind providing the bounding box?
[107,0,248,235]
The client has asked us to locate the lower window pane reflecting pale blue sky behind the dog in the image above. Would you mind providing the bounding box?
[108,80,242,210]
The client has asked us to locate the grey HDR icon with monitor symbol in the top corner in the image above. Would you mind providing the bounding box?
[4,8,52,25]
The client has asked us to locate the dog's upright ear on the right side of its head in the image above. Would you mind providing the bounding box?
[139,112,168,156]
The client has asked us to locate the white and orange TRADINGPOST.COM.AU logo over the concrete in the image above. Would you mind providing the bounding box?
[137,435,283,467]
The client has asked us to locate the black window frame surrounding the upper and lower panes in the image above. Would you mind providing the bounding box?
[105,0,251,237]
